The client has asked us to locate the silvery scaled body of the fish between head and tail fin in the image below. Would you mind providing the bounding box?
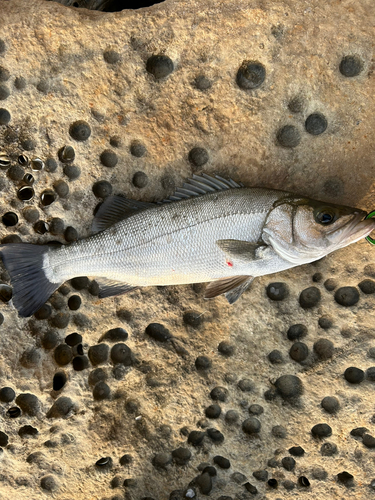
[49,188,287,286]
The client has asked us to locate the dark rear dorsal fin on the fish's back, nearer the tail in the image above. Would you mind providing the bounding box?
[92,195,155,233]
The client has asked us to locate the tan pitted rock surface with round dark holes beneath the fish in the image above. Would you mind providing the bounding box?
[0,0,375,500]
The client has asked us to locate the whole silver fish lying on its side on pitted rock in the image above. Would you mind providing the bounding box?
[0,174,375,317]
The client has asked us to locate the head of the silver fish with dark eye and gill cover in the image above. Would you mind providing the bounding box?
[262,197,375,265]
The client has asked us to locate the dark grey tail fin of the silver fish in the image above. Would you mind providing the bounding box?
[0,243,61,318]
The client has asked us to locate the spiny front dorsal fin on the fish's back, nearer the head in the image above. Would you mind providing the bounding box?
[163,174,243,202]
